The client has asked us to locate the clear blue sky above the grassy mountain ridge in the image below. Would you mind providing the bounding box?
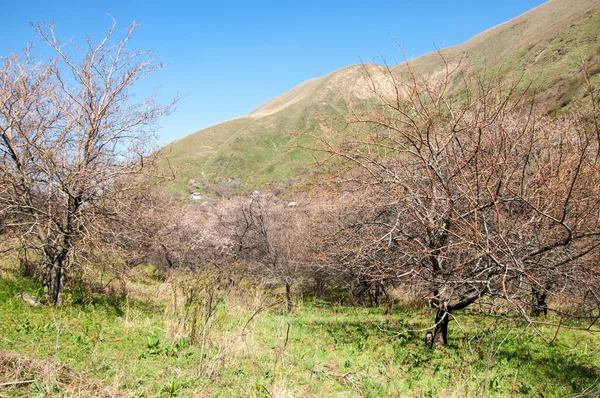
[0,0,544,144]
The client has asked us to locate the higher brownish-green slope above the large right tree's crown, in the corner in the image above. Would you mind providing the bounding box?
[393,0,600,113]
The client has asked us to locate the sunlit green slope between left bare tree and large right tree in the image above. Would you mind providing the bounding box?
[162,65,383,191]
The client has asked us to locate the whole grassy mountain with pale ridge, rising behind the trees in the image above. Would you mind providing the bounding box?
[161,0,600,195]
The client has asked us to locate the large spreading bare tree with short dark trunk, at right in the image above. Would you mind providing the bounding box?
[318,58,600,346]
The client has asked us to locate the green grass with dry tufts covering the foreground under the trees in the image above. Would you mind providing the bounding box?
[0,277,600,397]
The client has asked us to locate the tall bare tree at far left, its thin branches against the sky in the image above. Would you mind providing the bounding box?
[0,23,172,304]
